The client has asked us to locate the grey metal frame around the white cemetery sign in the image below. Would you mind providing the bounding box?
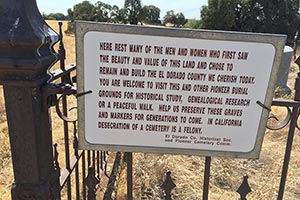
[75,21,286,158]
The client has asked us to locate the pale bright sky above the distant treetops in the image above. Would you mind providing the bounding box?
[36,0,207,19]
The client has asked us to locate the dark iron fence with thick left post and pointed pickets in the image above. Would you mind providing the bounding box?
[0,0,300,200]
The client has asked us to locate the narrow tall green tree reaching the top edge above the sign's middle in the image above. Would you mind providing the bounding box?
[124,0,143,25]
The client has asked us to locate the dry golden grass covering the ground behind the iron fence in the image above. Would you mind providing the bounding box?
[0,21,300,200]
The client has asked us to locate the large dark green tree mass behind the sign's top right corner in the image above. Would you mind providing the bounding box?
[201,0,299,39]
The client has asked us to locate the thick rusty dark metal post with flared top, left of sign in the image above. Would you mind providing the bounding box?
[0,0,59,200]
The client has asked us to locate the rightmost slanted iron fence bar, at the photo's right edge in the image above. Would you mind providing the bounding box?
[277,57,300,200]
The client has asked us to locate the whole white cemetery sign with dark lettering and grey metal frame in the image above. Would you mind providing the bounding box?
[76,22,286,158]
